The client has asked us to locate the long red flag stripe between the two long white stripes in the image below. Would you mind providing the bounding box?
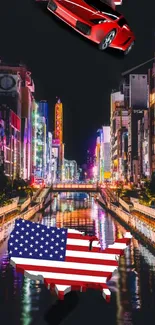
[16,264,112,278]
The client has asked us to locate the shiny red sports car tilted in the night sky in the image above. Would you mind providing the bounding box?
[37,0,135,55]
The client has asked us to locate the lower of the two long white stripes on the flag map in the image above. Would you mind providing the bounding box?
[25,270,107,283]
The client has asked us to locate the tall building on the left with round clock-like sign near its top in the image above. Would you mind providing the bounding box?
[0,63,34,180]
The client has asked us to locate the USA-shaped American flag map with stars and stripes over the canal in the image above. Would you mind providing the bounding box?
[8,219,131,301]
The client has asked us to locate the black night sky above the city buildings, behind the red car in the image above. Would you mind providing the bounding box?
[0,0,155,163]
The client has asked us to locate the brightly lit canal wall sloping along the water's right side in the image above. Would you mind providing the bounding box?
[97,199,155,249]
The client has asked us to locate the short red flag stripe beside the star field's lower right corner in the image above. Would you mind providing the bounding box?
[65,256,119,266]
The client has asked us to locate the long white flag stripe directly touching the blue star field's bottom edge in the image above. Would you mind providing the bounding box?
[11,257,118,272]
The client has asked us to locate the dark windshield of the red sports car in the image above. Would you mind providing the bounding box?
[84,0,121,20]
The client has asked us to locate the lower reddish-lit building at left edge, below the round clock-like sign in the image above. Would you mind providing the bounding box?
[0,105,21,180]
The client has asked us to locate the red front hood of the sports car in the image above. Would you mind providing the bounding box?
[57,0,121,21]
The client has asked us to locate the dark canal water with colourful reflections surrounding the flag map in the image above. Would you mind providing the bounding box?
[0,193,155,325]
